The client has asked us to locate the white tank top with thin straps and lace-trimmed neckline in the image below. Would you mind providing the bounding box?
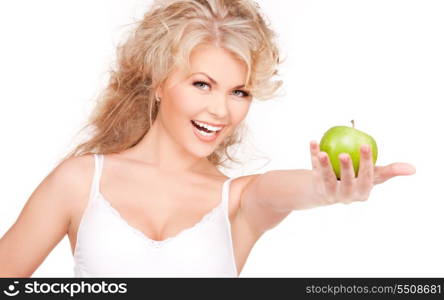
[73,154,237,277]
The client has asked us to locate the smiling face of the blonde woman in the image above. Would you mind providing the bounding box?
[158,45,252,157]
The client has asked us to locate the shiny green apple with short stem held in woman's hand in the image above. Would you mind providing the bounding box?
[319,121,378,180]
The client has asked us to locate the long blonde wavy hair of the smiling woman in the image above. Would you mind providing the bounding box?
[59,0,282,167]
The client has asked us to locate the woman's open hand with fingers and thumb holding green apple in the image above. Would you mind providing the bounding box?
[310,141,416,204]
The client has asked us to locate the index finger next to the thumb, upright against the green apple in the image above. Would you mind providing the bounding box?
[356,144,375,198]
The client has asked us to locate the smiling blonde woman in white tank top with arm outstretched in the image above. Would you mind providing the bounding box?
[0,0,414,277]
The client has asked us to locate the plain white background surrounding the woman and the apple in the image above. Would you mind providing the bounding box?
[0,0,444,277]
